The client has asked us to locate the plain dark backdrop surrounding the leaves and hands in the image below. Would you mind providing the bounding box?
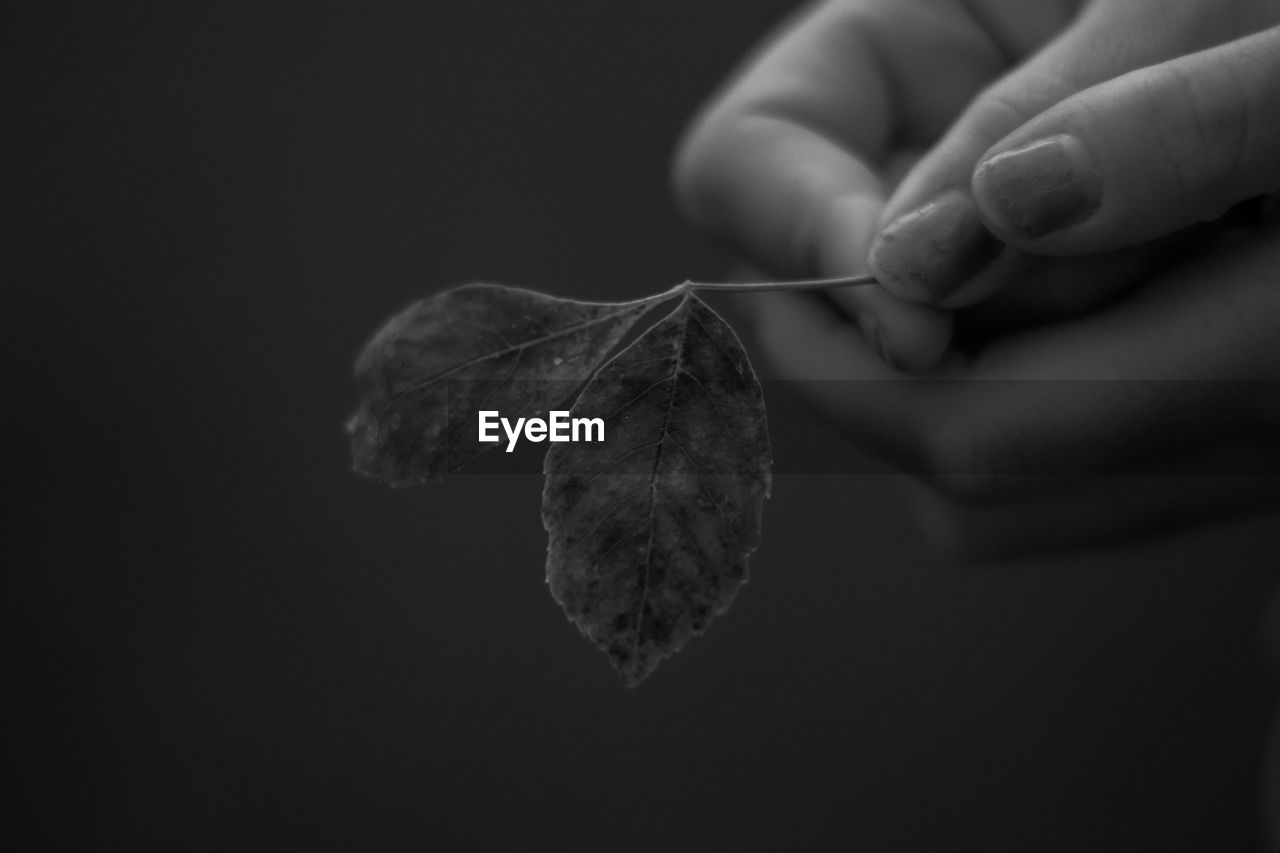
[10,0,1276,850]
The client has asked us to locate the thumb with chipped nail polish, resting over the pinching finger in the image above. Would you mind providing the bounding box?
[972,27,1280,255]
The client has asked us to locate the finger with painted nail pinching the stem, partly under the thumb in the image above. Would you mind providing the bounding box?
[869,0,1259,304]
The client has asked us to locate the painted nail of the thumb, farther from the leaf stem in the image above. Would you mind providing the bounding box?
[973,133,1102,237]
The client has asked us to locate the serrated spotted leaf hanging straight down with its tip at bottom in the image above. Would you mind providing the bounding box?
[543,295,771,686]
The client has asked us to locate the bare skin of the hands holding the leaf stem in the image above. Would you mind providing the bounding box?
[673,0,1280,835]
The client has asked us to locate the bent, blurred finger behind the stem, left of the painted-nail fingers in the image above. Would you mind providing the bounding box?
[673,0,1056,368]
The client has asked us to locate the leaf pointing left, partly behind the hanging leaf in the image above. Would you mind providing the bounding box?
[347,284,653,485]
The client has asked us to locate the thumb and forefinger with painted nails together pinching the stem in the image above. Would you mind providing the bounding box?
[870,0,1280,307]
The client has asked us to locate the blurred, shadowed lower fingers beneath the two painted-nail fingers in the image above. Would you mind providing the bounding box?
[751,212,1280,558]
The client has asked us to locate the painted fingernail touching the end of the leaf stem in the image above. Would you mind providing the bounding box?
[870,190,1000,302]
